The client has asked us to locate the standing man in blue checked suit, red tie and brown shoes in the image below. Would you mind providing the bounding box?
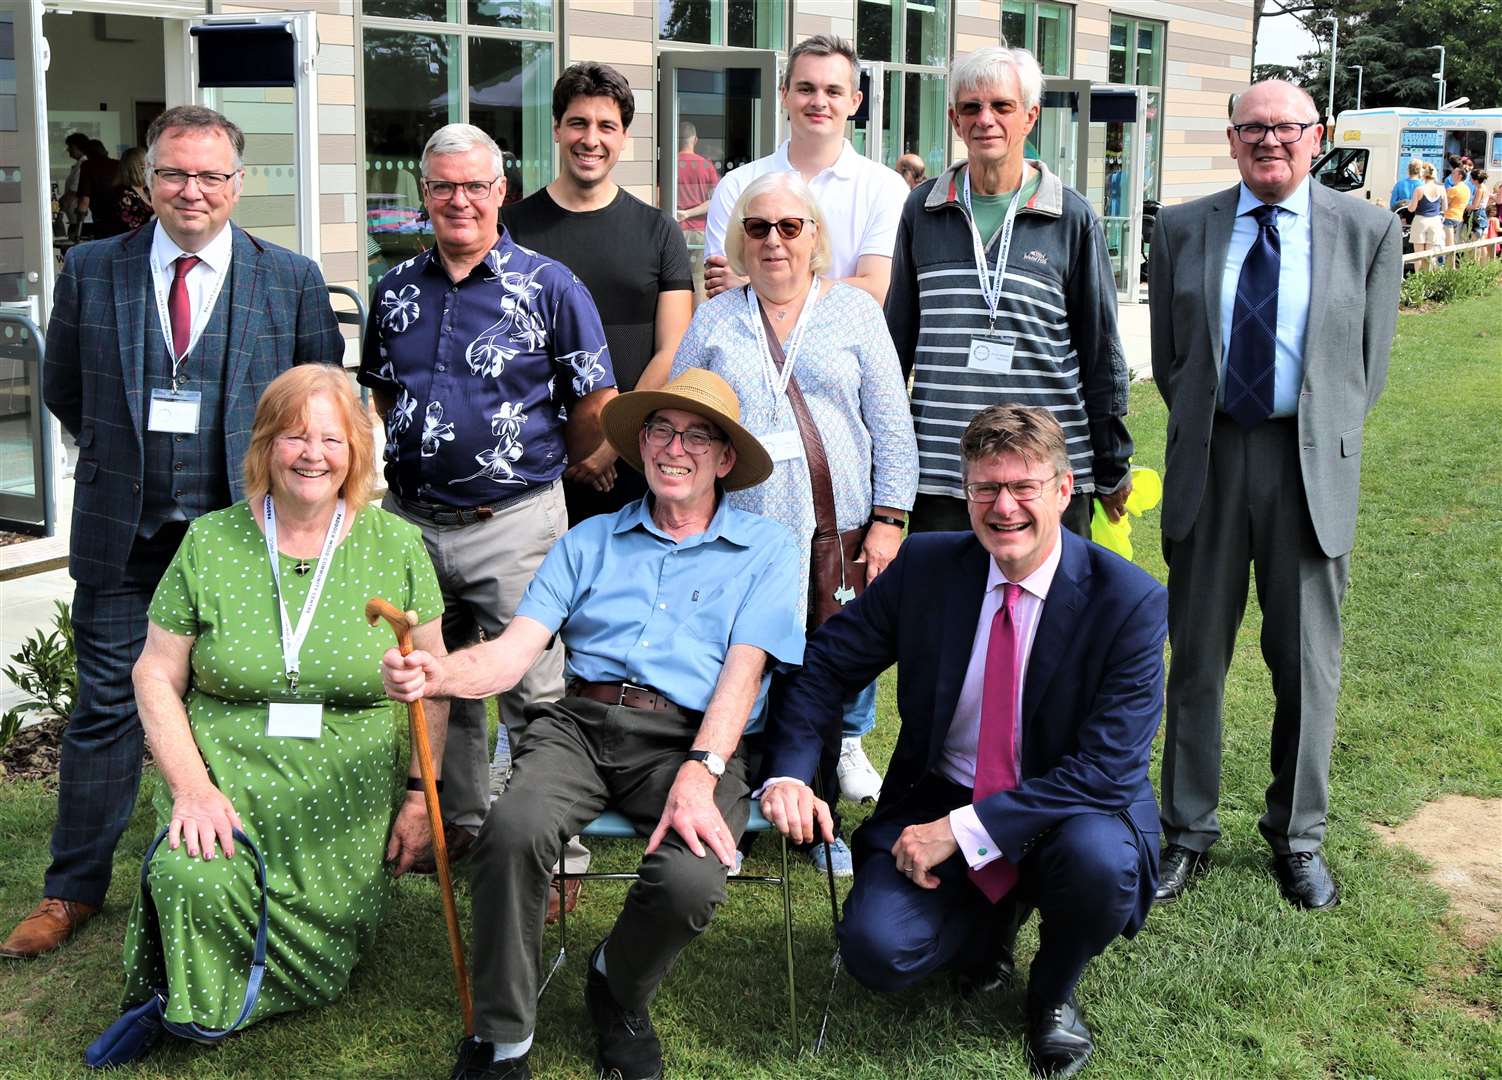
[0,107,344,957]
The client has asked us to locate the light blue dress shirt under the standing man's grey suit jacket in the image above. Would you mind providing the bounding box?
[1218,176,1314,416]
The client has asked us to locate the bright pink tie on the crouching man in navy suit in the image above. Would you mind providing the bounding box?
[970,581,1023,904]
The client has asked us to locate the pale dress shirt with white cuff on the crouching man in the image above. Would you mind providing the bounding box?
[939,536,1063,870]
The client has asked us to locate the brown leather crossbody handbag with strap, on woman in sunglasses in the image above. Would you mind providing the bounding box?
[757,303,870,632]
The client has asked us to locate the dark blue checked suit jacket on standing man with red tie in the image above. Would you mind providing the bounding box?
[42,222,344,587]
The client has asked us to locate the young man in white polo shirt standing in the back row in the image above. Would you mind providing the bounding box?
[704,35,907,303]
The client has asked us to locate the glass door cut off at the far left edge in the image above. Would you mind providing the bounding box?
[0,3,54,535]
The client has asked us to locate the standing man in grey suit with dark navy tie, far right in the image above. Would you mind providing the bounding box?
[1149,81,1403,909]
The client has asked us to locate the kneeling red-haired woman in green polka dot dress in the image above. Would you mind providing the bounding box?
[125,365,448,1030]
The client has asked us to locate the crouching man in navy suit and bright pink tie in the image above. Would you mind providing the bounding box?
[762,406,1167,1075]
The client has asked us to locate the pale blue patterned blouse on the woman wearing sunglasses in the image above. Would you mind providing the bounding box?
[673,284,918,610]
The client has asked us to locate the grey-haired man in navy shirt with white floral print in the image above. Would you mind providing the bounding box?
[359,123,616,858]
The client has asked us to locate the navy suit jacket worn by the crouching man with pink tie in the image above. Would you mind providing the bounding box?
[763,532,1169,931]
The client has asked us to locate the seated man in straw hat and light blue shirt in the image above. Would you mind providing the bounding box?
[382,370,804,1080]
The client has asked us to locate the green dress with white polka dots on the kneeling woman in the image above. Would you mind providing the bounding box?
[125,503,443,1029]
